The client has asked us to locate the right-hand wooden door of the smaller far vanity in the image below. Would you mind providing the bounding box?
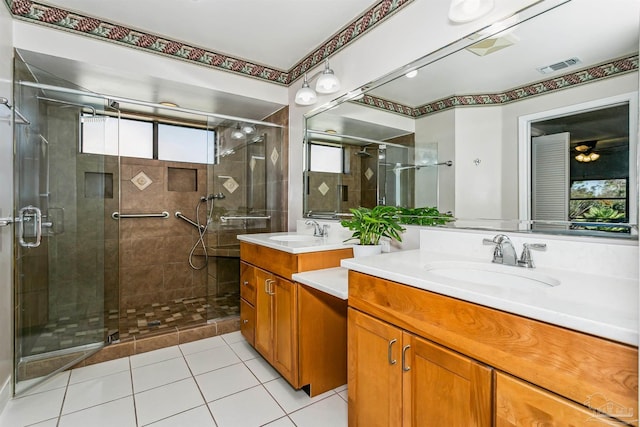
[272,277,298,388]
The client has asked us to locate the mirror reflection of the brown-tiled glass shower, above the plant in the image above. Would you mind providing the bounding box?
[305,131,452,217]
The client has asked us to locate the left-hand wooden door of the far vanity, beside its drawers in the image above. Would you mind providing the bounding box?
[255,268,275,360]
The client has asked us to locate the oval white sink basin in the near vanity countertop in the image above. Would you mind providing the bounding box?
[425,261,560,286]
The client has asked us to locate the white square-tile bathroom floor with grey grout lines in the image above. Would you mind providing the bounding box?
[0,332,347,427]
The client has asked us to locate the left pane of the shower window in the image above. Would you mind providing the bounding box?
[80,115,153,159]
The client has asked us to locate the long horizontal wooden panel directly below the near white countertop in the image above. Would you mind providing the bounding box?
[349,271,638,422]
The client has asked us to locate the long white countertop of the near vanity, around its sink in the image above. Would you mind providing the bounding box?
[341,250,638,346]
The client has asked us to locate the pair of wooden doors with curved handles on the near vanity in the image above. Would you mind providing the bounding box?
[348,309,492,427]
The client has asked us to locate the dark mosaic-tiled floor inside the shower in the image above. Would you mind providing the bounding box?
[25,293,240,356]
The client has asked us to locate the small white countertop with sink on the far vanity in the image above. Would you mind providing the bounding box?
[238,232,353,254]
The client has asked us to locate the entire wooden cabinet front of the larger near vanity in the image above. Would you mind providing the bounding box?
[348,271,638,427]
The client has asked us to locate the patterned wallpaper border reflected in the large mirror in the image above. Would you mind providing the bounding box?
[352,55,638,118]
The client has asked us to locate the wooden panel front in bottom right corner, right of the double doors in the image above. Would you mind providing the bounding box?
[495,373,637,427]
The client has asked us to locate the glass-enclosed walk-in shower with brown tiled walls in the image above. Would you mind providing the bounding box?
[14,51,286,394]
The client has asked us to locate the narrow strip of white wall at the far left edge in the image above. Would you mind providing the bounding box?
[0,4,13,412]
